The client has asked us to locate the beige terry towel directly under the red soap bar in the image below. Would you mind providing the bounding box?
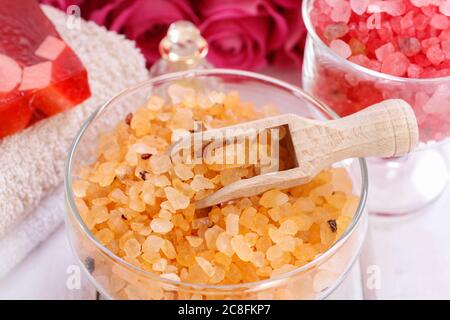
[0,6,148,241]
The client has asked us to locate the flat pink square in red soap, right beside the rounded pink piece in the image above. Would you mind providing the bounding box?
[19,61,52,91]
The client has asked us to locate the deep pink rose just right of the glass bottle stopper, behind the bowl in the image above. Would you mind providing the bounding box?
[198,0,288,70]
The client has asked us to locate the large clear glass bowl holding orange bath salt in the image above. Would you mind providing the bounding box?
[65,69,368,299]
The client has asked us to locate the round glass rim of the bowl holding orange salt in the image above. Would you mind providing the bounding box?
[64,68,368,292]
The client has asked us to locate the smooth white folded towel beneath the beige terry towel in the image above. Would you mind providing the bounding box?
[0,185,64,278]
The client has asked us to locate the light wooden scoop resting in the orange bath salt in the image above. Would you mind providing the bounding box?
[170,99,419,209]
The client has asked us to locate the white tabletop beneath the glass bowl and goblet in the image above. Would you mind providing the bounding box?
[0,69,450,299]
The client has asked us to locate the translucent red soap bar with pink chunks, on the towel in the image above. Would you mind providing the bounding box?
[0,0,91,138]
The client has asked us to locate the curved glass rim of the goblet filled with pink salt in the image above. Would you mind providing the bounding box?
[301,0,450,84]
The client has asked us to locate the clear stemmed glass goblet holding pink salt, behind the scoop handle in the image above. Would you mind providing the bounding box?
[302,0,450,214]
